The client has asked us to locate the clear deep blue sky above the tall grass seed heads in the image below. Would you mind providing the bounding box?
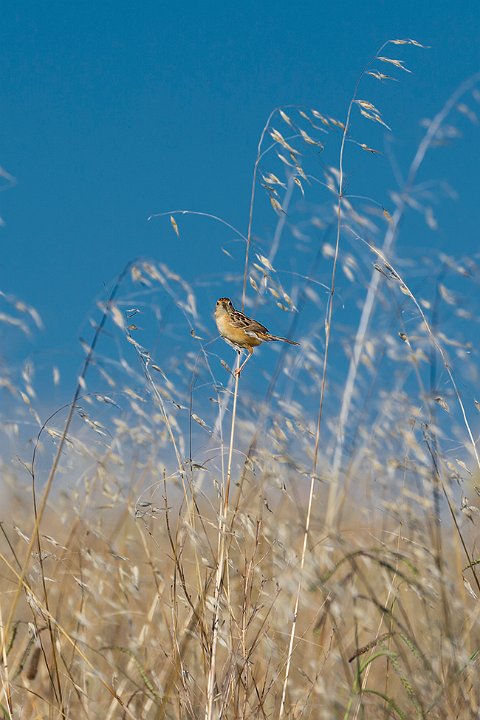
[0,0,480,396]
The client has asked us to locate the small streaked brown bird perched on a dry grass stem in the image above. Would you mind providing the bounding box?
[215,298,300,376]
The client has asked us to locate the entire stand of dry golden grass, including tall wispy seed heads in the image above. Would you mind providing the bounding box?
[0,40,480,720]
